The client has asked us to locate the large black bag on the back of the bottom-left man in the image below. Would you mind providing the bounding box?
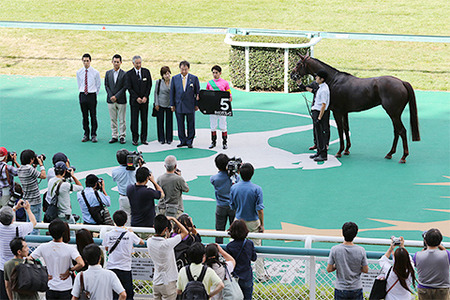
[11,259,48,295]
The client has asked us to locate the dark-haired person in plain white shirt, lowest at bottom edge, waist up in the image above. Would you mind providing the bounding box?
[72,244,127,300]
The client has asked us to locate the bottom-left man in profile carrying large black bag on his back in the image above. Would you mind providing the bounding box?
[4,237,40,300]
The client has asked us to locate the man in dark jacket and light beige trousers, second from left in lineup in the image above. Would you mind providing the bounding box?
[105,54,127,144]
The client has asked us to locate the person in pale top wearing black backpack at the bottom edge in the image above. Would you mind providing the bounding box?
[177,243,224,300]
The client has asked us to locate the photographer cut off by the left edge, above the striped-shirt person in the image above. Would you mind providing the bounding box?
[0,147,20,208]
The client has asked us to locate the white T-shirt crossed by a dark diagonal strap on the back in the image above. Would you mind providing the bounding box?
[102,227,141,271]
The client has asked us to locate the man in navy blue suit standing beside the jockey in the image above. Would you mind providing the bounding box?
[170,60,200,148]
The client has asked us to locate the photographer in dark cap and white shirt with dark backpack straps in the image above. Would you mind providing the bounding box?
[47,161,83,224]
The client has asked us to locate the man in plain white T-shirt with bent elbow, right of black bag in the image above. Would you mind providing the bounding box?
[30,219,84,299]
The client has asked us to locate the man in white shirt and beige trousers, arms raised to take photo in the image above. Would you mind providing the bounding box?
[147,215,189,300]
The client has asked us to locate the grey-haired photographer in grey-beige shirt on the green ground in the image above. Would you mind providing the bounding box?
[158,155,189,218]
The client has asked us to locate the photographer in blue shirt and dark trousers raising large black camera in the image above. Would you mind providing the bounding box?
[210,153,236,244]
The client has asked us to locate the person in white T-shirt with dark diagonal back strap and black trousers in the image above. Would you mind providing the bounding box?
[103,210,144,299]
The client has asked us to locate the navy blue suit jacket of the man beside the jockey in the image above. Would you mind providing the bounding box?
[170,74,200,114]
